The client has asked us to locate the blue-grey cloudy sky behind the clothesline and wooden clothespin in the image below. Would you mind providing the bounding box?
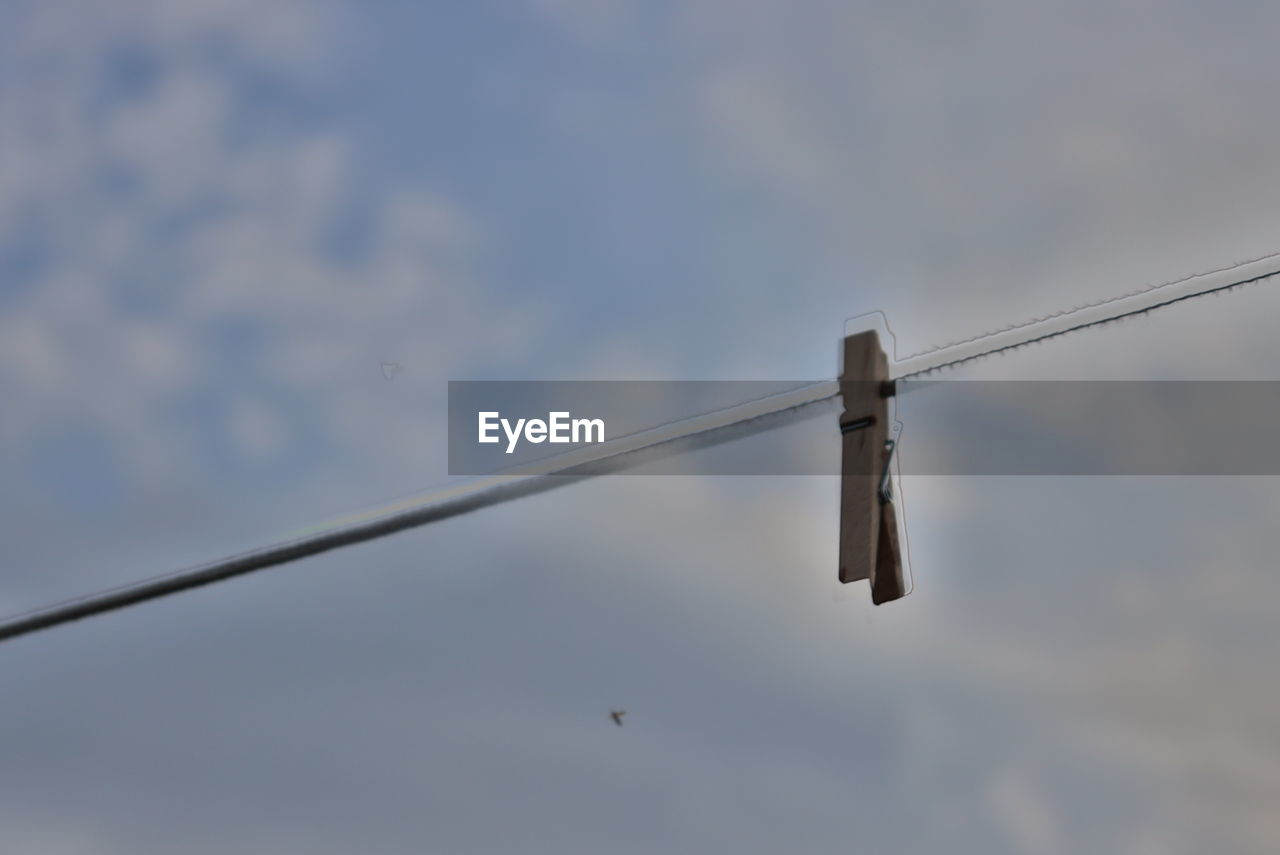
[0,0,1280,855]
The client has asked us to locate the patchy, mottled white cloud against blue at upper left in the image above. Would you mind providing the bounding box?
[0,3,536,494]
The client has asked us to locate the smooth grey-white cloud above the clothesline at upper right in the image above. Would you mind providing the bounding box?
[676,0,1280,349]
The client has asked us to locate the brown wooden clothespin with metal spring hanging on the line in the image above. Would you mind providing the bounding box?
[840,330,910,605]
